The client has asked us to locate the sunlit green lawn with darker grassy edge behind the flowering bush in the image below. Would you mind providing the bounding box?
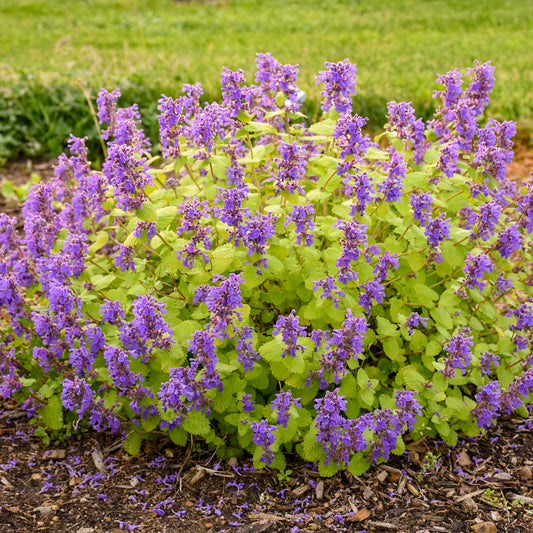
[0,0,533,160]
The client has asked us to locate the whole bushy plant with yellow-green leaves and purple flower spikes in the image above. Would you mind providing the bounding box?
[0,54,533,475]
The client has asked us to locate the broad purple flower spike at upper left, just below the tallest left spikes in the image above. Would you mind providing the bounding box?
[102,143,153,211]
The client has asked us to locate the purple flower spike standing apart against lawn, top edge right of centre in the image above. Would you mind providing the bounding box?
[316,59,357,113]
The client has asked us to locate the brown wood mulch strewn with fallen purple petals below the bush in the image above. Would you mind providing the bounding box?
[0,406,533,533]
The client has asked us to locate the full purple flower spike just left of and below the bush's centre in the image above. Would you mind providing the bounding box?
[193,273,244,339]
